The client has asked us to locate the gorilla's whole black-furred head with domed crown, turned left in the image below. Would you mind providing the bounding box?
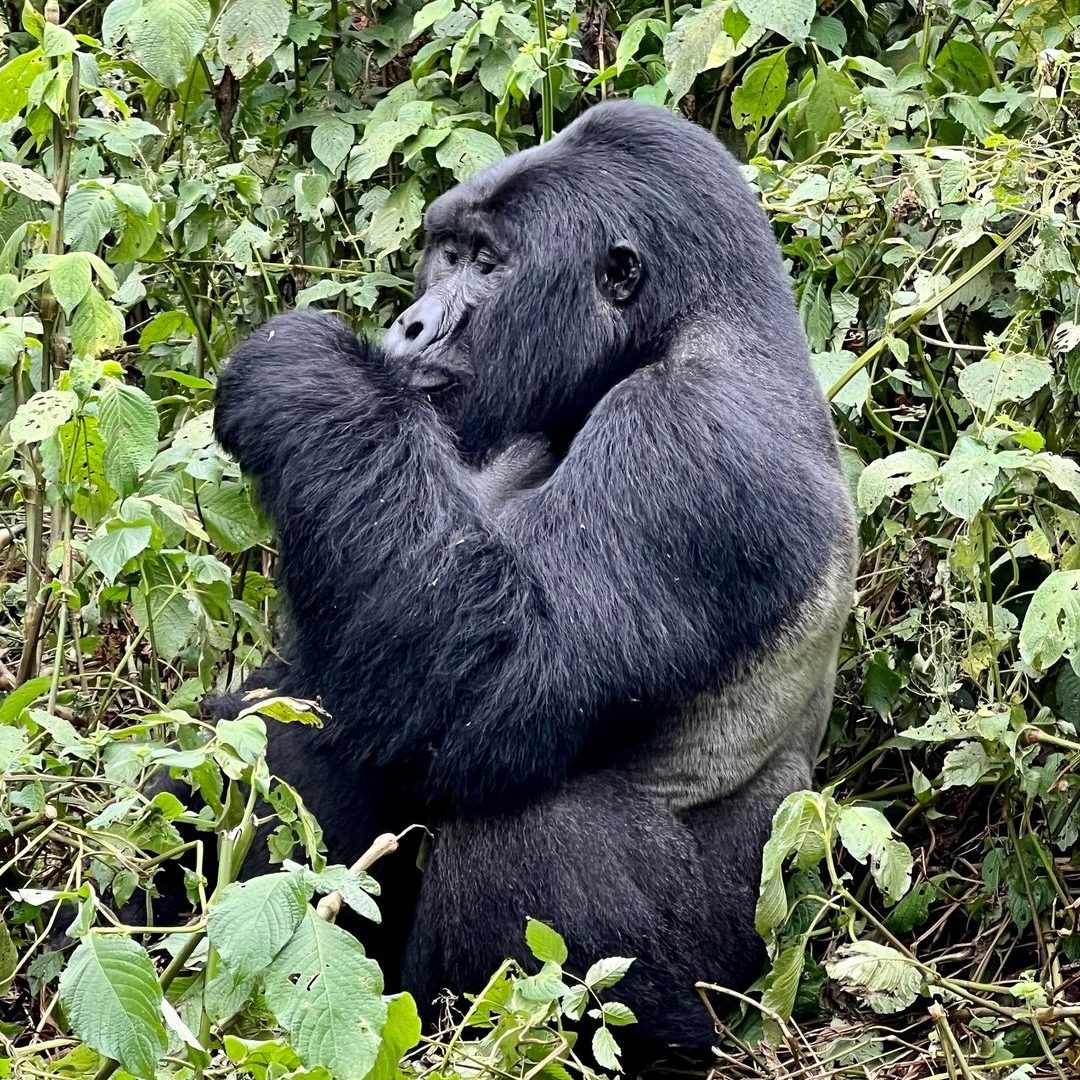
[384,102,791,455]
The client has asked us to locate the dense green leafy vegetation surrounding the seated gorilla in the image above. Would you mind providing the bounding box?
[0,0,1080,1080]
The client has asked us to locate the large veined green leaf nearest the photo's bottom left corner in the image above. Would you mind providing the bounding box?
[59,933,168,1080]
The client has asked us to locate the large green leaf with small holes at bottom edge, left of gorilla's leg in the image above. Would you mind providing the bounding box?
[265,906,388,1080]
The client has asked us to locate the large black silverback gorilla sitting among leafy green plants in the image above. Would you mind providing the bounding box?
[215,103,854,1047]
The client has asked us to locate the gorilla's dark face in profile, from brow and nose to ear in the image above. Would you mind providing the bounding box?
[383,167,646,453]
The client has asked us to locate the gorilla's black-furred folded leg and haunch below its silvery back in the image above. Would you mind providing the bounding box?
[404,759,807,1049]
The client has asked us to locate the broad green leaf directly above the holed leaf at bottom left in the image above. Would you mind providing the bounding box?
[206,869,312,978]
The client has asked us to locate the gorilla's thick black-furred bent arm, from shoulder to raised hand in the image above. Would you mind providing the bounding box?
[216,312,831,809]
